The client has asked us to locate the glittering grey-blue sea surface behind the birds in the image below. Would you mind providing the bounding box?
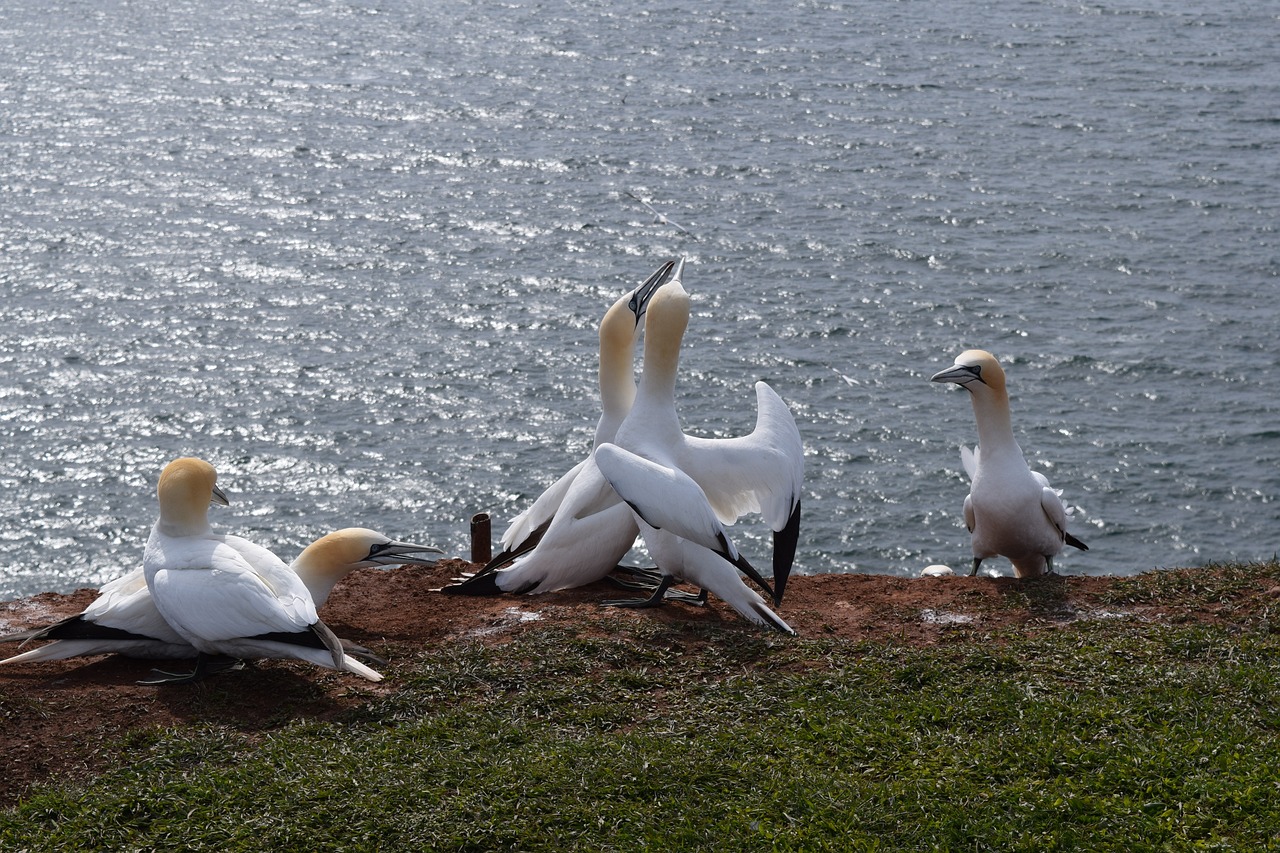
[0,0,1280,598]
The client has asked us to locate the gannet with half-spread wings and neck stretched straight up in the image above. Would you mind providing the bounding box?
[595,272,804,633]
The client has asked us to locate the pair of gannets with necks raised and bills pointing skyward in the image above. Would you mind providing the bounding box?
[444,260,804,631]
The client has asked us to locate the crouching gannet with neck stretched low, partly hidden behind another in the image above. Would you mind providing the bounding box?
[0,525,443,665]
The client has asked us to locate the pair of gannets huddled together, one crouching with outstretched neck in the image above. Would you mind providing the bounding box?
[0,459,443,681]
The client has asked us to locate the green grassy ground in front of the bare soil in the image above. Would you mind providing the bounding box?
[0,562,1280,852]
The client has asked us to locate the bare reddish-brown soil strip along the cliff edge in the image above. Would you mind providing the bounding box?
[0,560,1280,807]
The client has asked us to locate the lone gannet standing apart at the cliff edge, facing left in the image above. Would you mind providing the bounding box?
[931,350,1089,578]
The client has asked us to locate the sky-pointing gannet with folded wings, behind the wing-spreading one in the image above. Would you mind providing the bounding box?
[444,261,684,596]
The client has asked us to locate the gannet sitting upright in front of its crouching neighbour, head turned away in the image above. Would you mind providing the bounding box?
[142,457,383,684]
